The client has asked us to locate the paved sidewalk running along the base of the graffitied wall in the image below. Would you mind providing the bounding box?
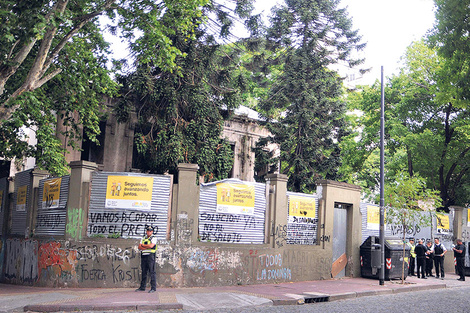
[0,274,470,312]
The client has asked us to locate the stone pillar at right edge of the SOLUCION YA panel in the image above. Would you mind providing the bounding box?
[266,174,288,248]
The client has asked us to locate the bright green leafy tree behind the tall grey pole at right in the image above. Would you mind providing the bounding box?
[342,41,470,210]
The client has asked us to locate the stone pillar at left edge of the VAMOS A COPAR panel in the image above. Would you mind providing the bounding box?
[65,161,98,240]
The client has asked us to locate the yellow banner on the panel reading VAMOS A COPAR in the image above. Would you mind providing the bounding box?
[105,176,153,210]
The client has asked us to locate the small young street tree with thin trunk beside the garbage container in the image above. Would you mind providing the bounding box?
[384,172,440,283]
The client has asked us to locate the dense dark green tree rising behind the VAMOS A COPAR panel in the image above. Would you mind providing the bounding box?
[118,1,258,181]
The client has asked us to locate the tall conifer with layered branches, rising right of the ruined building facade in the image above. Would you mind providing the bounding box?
[259,0,364,192]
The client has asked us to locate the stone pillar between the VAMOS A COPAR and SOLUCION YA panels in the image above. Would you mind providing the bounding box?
[175,163,199,245]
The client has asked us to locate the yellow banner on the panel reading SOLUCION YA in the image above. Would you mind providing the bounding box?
[216,183,255,215]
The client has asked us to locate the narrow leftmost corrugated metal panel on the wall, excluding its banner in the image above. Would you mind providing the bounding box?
[11,169,33,235]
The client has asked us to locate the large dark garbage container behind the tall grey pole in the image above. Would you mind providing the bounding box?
[360,236,410,280]
